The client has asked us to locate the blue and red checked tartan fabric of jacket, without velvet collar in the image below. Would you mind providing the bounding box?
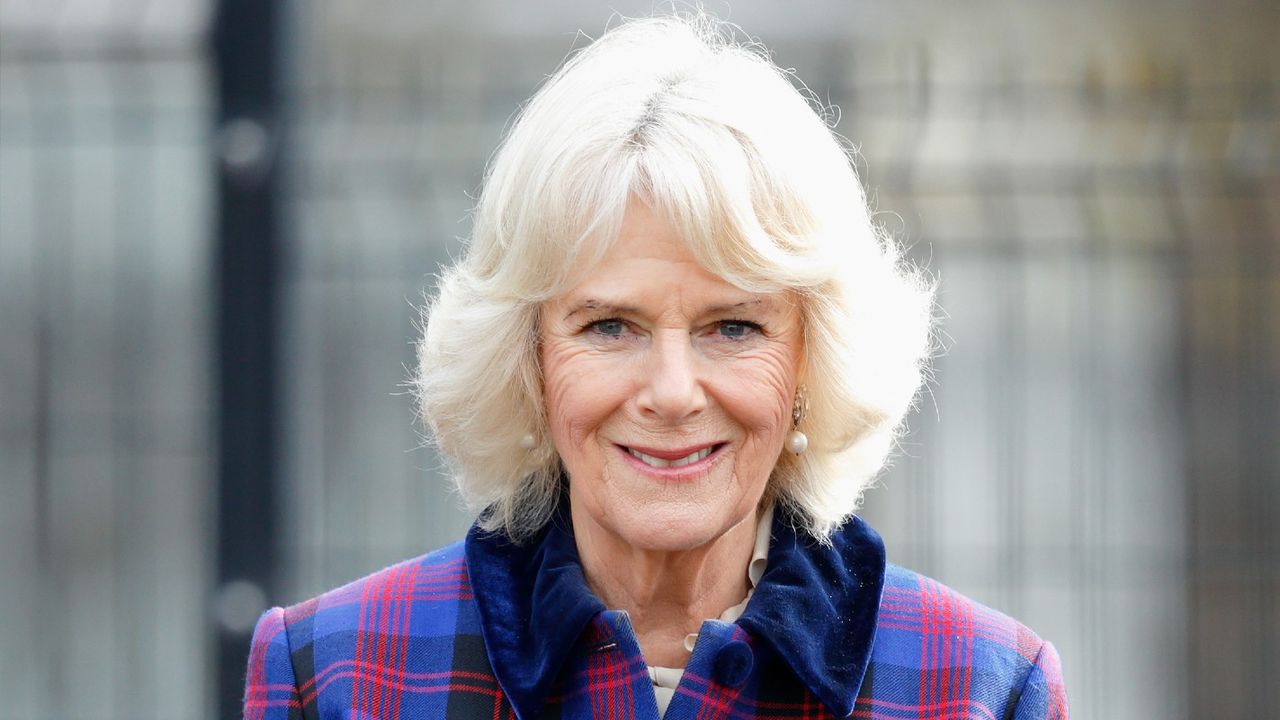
[244,525,1068,720]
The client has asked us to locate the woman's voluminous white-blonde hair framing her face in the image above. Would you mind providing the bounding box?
[413,15,933,542]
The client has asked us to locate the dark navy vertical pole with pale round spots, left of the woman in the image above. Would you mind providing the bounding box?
[211,0,283,719]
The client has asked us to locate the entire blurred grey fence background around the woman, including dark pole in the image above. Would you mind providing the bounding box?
[0,0,1280,720]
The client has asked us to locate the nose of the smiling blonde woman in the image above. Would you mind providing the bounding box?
[636,332,707,425]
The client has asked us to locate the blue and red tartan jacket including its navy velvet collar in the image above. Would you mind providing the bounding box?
[244,504,1068,720]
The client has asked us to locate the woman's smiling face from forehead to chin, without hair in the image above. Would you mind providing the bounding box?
[541,201,803,551]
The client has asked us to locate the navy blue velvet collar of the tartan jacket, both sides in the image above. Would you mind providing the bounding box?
[466,500,884,719]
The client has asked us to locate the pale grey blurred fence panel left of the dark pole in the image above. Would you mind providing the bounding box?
[0,33,214,720]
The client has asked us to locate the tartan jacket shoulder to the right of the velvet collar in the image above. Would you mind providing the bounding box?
[868,564,1066,717]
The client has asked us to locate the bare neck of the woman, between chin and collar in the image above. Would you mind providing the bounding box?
[572,502,759,667]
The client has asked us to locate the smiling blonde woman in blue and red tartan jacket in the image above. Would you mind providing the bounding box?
[244,12,1066,720]
